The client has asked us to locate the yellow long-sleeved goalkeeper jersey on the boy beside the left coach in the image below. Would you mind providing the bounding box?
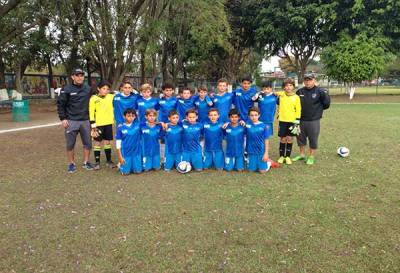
[89,94,114,126]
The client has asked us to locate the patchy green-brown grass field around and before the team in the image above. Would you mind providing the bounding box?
[0,104,400,273]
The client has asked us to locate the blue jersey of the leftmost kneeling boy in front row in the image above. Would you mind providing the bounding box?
[115,120,142,157]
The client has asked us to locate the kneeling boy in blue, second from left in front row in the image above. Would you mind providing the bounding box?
[141,109,162,171]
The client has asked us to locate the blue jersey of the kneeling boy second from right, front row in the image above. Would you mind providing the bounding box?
[225,124,246,157]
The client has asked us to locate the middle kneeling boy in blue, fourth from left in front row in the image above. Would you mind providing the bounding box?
[182,109,203,171]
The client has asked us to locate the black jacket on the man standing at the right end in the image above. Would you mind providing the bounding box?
[296,86,331,121]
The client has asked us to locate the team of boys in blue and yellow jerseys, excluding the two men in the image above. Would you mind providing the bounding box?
[89,77,301,174]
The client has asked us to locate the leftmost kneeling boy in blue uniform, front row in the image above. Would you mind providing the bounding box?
[115,109,143,175]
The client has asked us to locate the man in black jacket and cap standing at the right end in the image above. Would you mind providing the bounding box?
[293,74,331,165]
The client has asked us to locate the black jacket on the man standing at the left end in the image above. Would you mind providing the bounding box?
[57,84,91,120]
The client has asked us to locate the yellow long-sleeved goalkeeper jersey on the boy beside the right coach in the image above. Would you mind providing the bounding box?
[275,91,301,122]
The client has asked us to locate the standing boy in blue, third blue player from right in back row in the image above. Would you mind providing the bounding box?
[212,79,234,122]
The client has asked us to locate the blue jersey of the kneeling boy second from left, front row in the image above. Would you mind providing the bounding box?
[141,123,162,157]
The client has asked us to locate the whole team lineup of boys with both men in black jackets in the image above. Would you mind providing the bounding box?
[57,69,330,175]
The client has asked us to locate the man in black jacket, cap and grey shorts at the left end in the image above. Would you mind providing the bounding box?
[57,68,93,173]
